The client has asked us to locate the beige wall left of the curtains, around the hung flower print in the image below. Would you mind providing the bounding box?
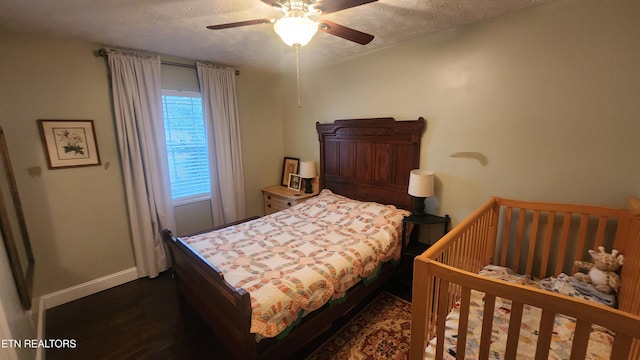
[0,31,135,296]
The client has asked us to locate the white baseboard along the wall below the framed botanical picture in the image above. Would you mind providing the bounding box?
[36,267,138,360]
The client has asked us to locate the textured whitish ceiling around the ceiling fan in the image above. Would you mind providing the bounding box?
[0,0,552,71]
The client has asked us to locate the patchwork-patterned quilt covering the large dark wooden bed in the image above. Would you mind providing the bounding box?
[183,189,409,338]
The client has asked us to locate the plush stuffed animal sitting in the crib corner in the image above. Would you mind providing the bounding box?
[573,246,624,294]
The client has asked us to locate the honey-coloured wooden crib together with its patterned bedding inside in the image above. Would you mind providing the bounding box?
[410,197,640,360]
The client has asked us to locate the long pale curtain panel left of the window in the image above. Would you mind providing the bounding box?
[107,50,175,278]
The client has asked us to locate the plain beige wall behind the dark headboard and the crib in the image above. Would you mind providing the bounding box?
[282,0,640,223]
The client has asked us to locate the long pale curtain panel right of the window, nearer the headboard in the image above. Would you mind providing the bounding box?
[196,62,246,225]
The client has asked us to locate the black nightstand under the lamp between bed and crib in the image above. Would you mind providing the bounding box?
[401,214,450,286]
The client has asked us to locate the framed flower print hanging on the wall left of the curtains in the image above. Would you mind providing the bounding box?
[38,119,100,169]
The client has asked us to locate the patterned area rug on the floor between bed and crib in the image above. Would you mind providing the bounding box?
[307,292,411,360]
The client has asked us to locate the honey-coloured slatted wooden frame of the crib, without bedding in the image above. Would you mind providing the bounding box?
[410,197,640,360]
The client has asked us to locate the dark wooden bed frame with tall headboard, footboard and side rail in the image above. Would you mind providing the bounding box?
[163,118,425,360]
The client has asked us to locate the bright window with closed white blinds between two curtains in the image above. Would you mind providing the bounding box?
[162,90,211,203]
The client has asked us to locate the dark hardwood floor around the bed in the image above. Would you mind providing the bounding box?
[45,271,411,360]
